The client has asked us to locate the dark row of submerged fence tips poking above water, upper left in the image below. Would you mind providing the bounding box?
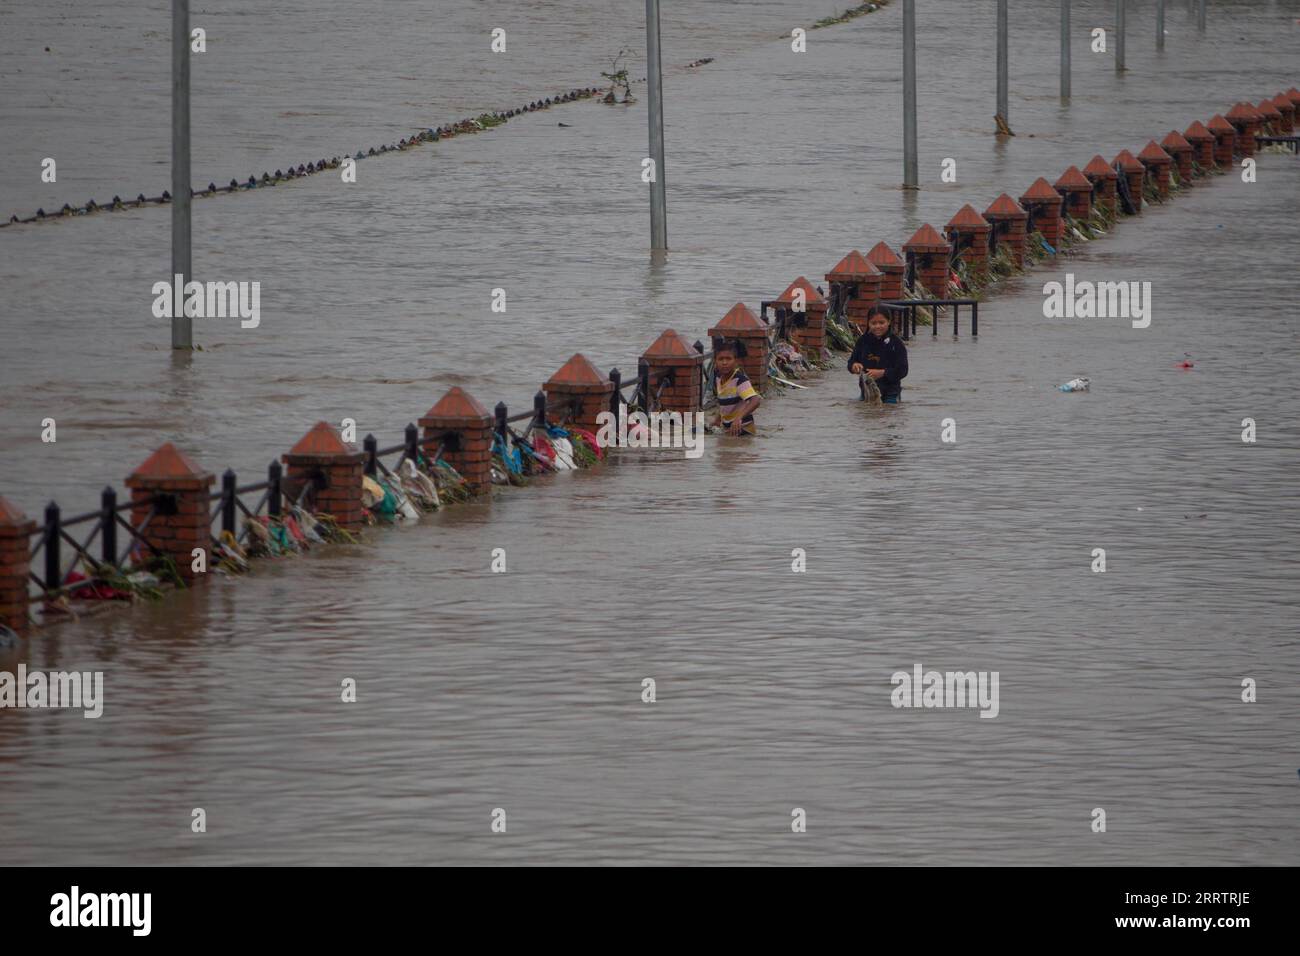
[0,86,601,229]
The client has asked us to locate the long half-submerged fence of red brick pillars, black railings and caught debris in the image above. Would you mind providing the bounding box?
[0,87,1300,631]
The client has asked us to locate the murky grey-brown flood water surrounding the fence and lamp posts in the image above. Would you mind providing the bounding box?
[0,0,1300,865]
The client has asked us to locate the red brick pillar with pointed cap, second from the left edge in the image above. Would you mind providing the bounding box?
[126,442,216,584]
